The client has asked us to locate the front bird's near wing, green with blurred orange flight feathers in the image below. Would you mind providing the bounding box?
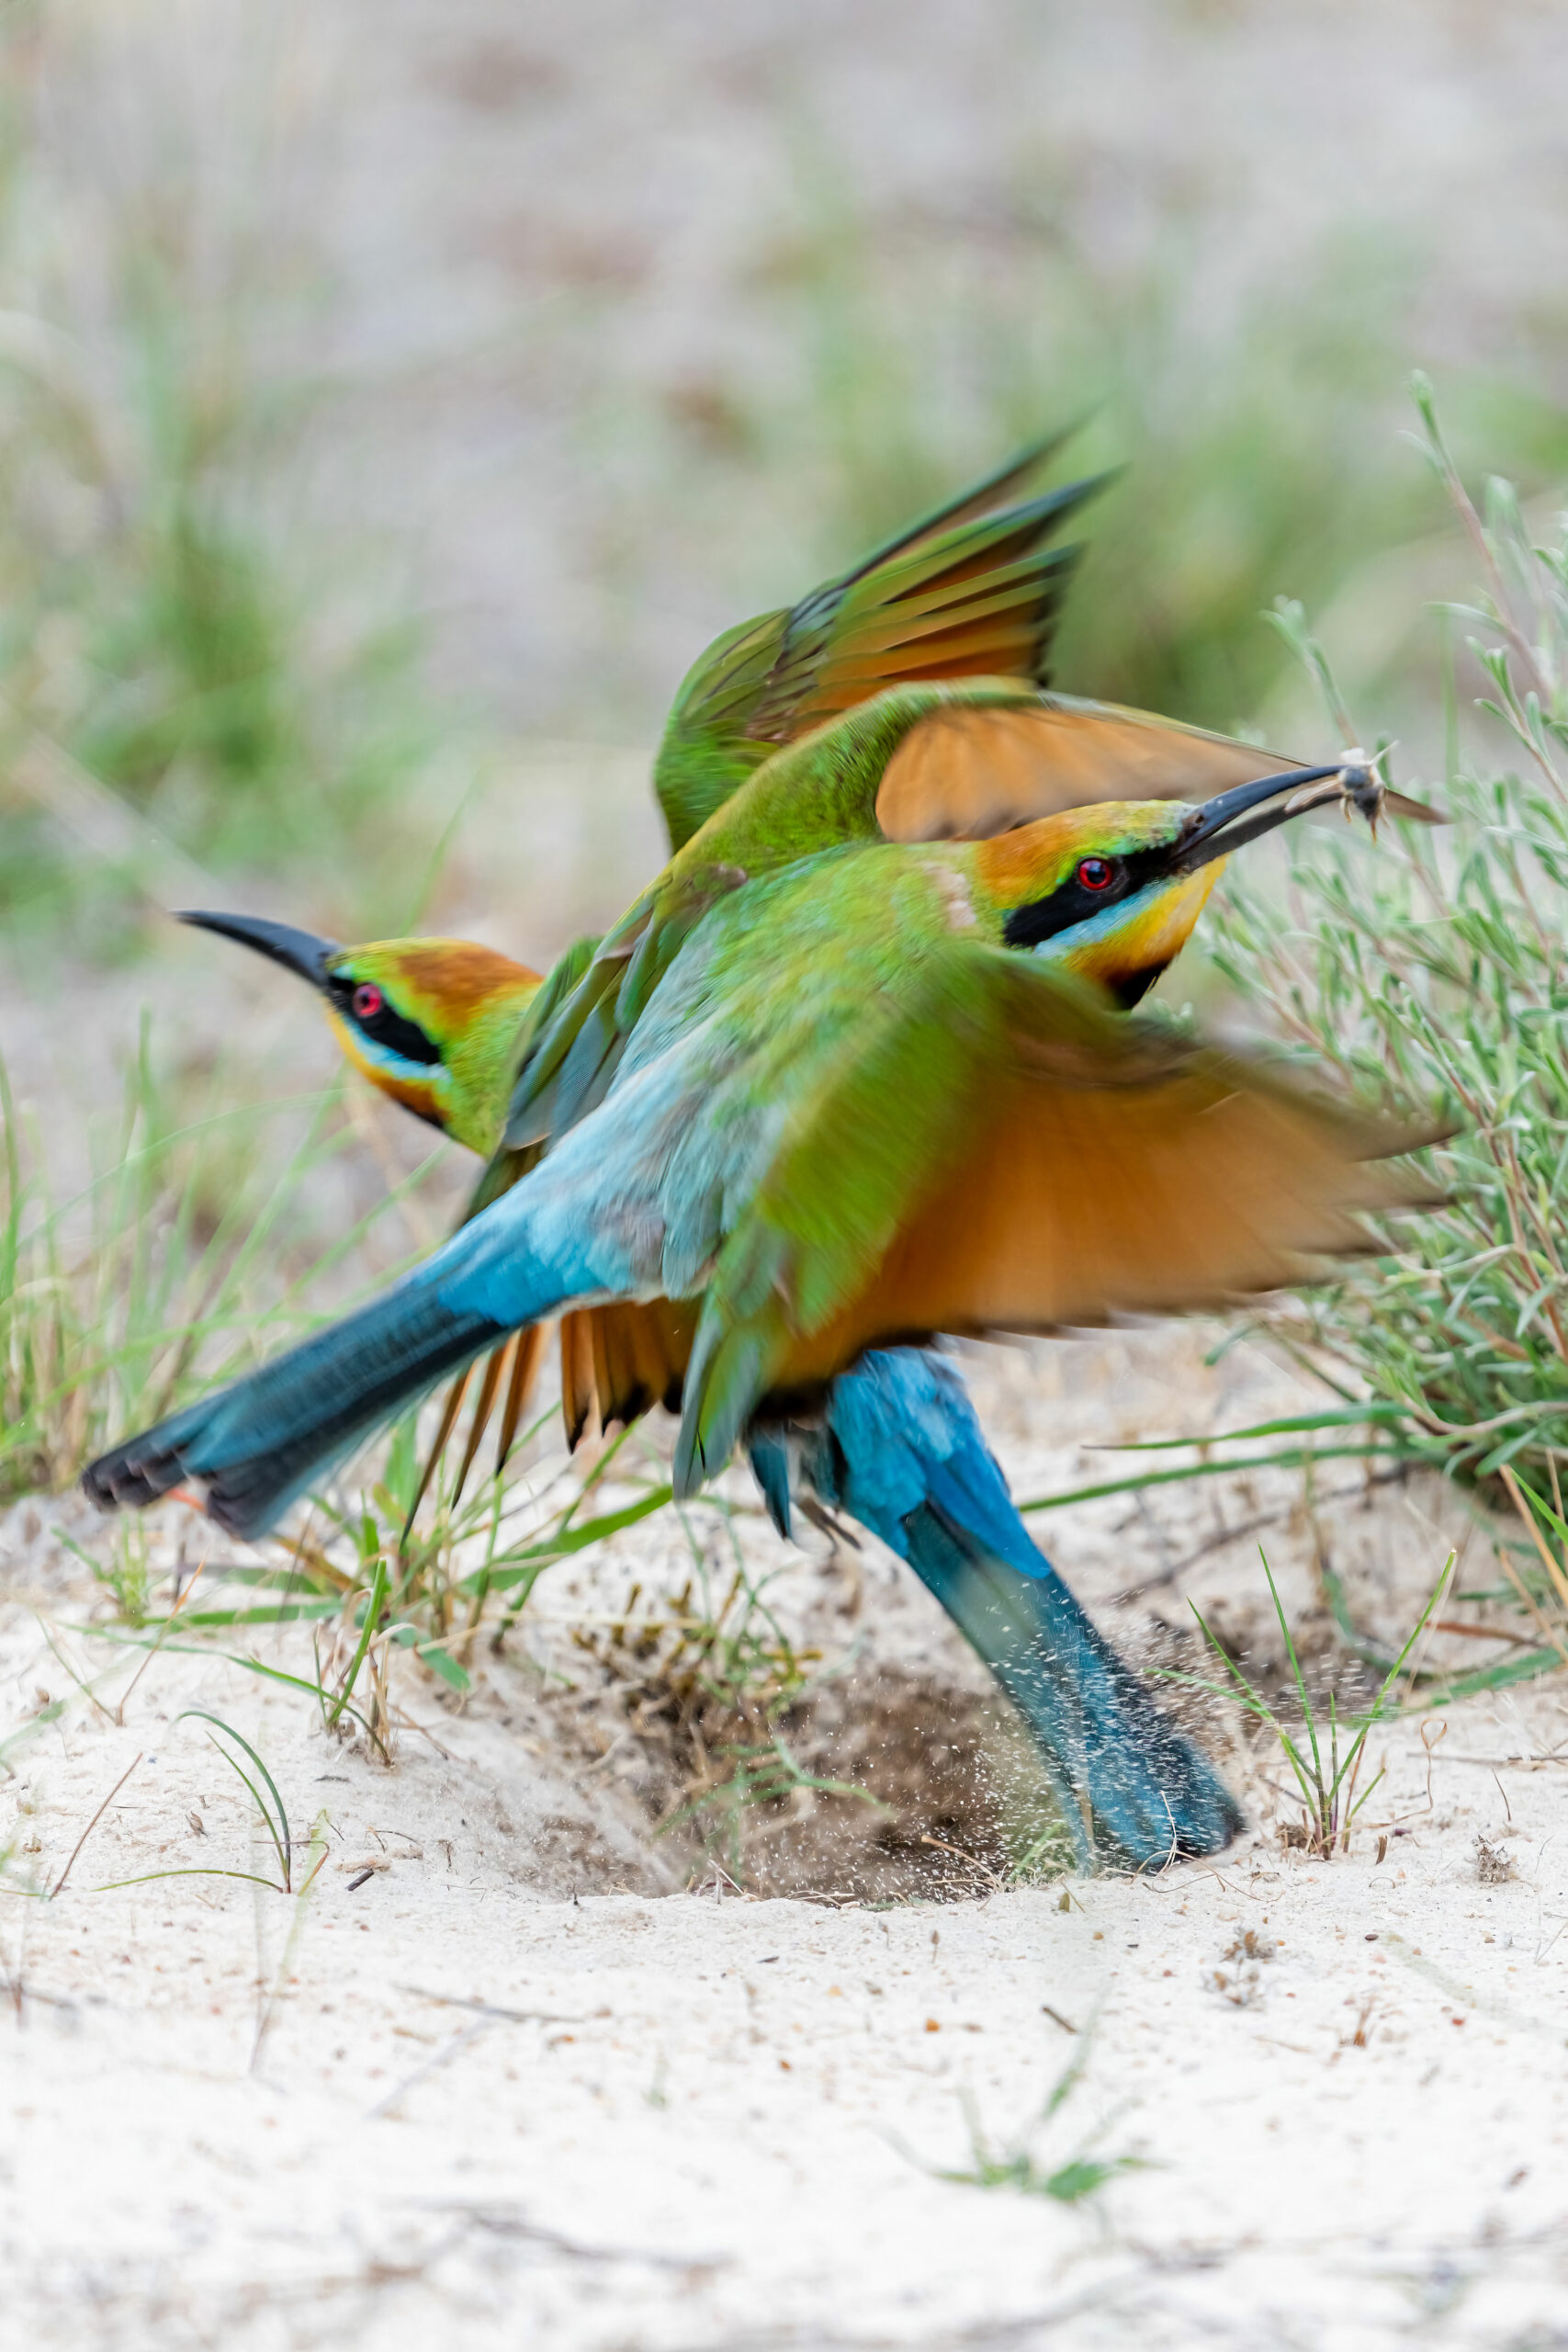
[677,944,1432,1491]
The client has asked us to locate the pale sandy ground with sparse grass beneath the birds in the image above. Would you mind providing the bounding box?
[0,1334,1568,2352]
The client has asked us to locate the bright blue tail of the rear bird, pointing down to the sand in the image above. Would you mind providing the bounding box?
[752,1348,1241,1868]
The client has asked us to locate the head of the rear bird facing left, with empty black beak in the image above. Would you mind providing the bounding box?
[179,912,541,1155]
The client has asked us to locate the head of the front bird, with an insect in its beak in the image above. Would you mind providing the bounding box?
[974,767,1380,1007]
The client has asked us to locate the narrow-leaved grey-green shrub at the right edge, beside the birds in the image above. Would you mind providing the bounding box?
[1215,383,1568,1517]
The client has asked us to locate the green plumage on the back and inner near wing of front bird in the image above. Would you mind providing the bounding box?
[644,844,1100,1484]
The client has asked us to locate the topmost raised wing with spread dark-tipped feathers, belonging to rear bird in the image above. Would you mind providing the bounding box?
[653,435,1107,852]
